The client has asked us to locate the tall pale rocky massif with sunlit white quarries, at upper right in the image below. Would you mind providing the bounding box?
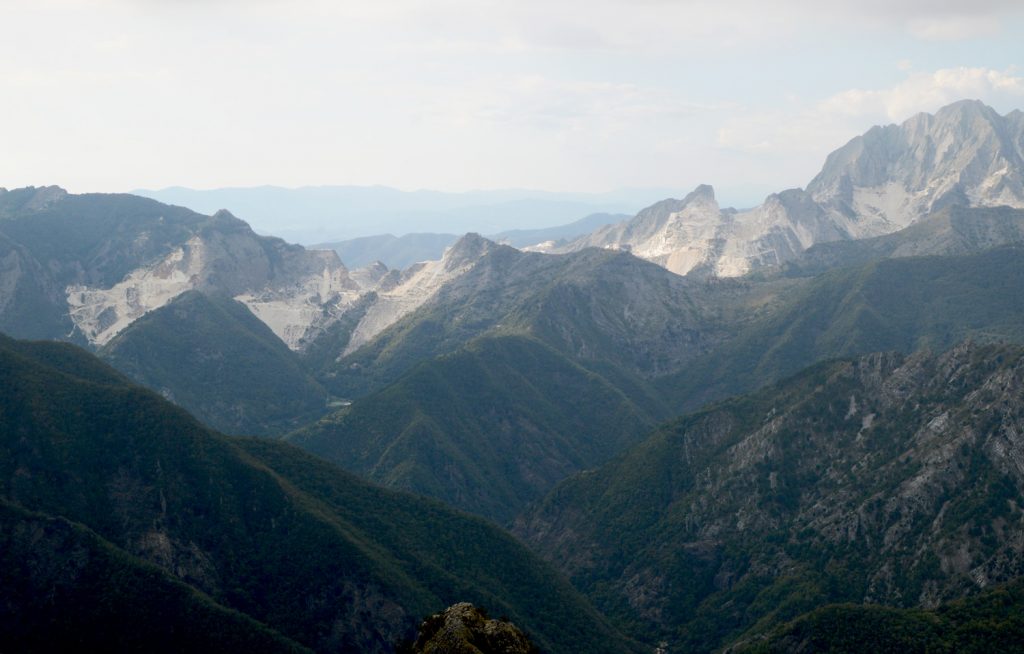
[550,100,1024,276]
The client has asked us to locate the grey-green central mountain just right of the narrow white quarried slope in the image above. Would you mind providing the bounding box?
[313,234,730,395]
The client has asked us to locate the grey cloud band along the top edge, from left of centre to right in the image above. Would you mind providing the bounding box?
[385,0,1024,52]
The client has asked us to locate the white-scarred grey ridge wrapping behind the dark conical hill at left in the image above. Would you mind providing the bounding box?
[67,216,359,349]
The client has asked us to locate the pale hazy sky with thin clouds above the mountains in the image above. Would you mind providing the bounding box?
[0,0,1024,206]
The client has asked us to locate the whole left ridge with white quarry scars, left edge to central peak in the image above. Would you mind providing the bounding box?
[0,186,494,350]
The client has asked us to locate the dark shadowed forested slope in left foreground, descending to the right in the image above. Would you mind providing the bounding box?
[0,338,631,652]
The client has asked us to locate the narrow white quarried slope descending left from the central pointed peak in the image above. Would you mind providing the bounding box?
[344,233,496,354]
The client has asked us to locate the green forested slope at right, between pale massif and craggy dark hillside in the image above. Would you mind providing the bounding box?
[657,244,1024,408]
